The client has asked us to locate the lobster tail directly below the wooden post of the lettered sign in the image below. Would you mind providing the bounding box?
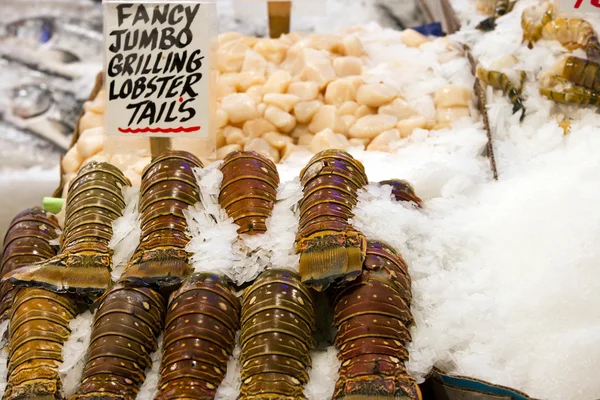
[121,151,202,288]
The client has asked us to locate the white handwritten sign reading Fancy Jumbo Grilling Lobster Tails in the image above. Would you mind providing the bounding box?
[104,2,216,138]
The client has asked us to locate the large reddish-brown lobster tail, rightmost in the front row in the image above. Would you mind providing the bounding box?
[333,241,421,400]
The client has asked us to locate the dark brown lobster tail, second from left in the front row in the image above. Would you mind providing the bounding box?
[70,284,165,400]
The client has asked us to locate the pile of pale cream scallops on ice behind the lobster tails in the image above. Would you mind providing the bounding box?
[62,24,479,192]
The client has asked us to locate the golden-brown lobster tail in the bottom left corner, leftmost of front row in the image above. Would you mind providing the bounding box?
[3,288,78,400]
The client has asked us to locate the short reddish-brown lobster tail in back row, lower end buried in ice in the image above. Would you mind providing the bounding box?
[219,151,279,235]
